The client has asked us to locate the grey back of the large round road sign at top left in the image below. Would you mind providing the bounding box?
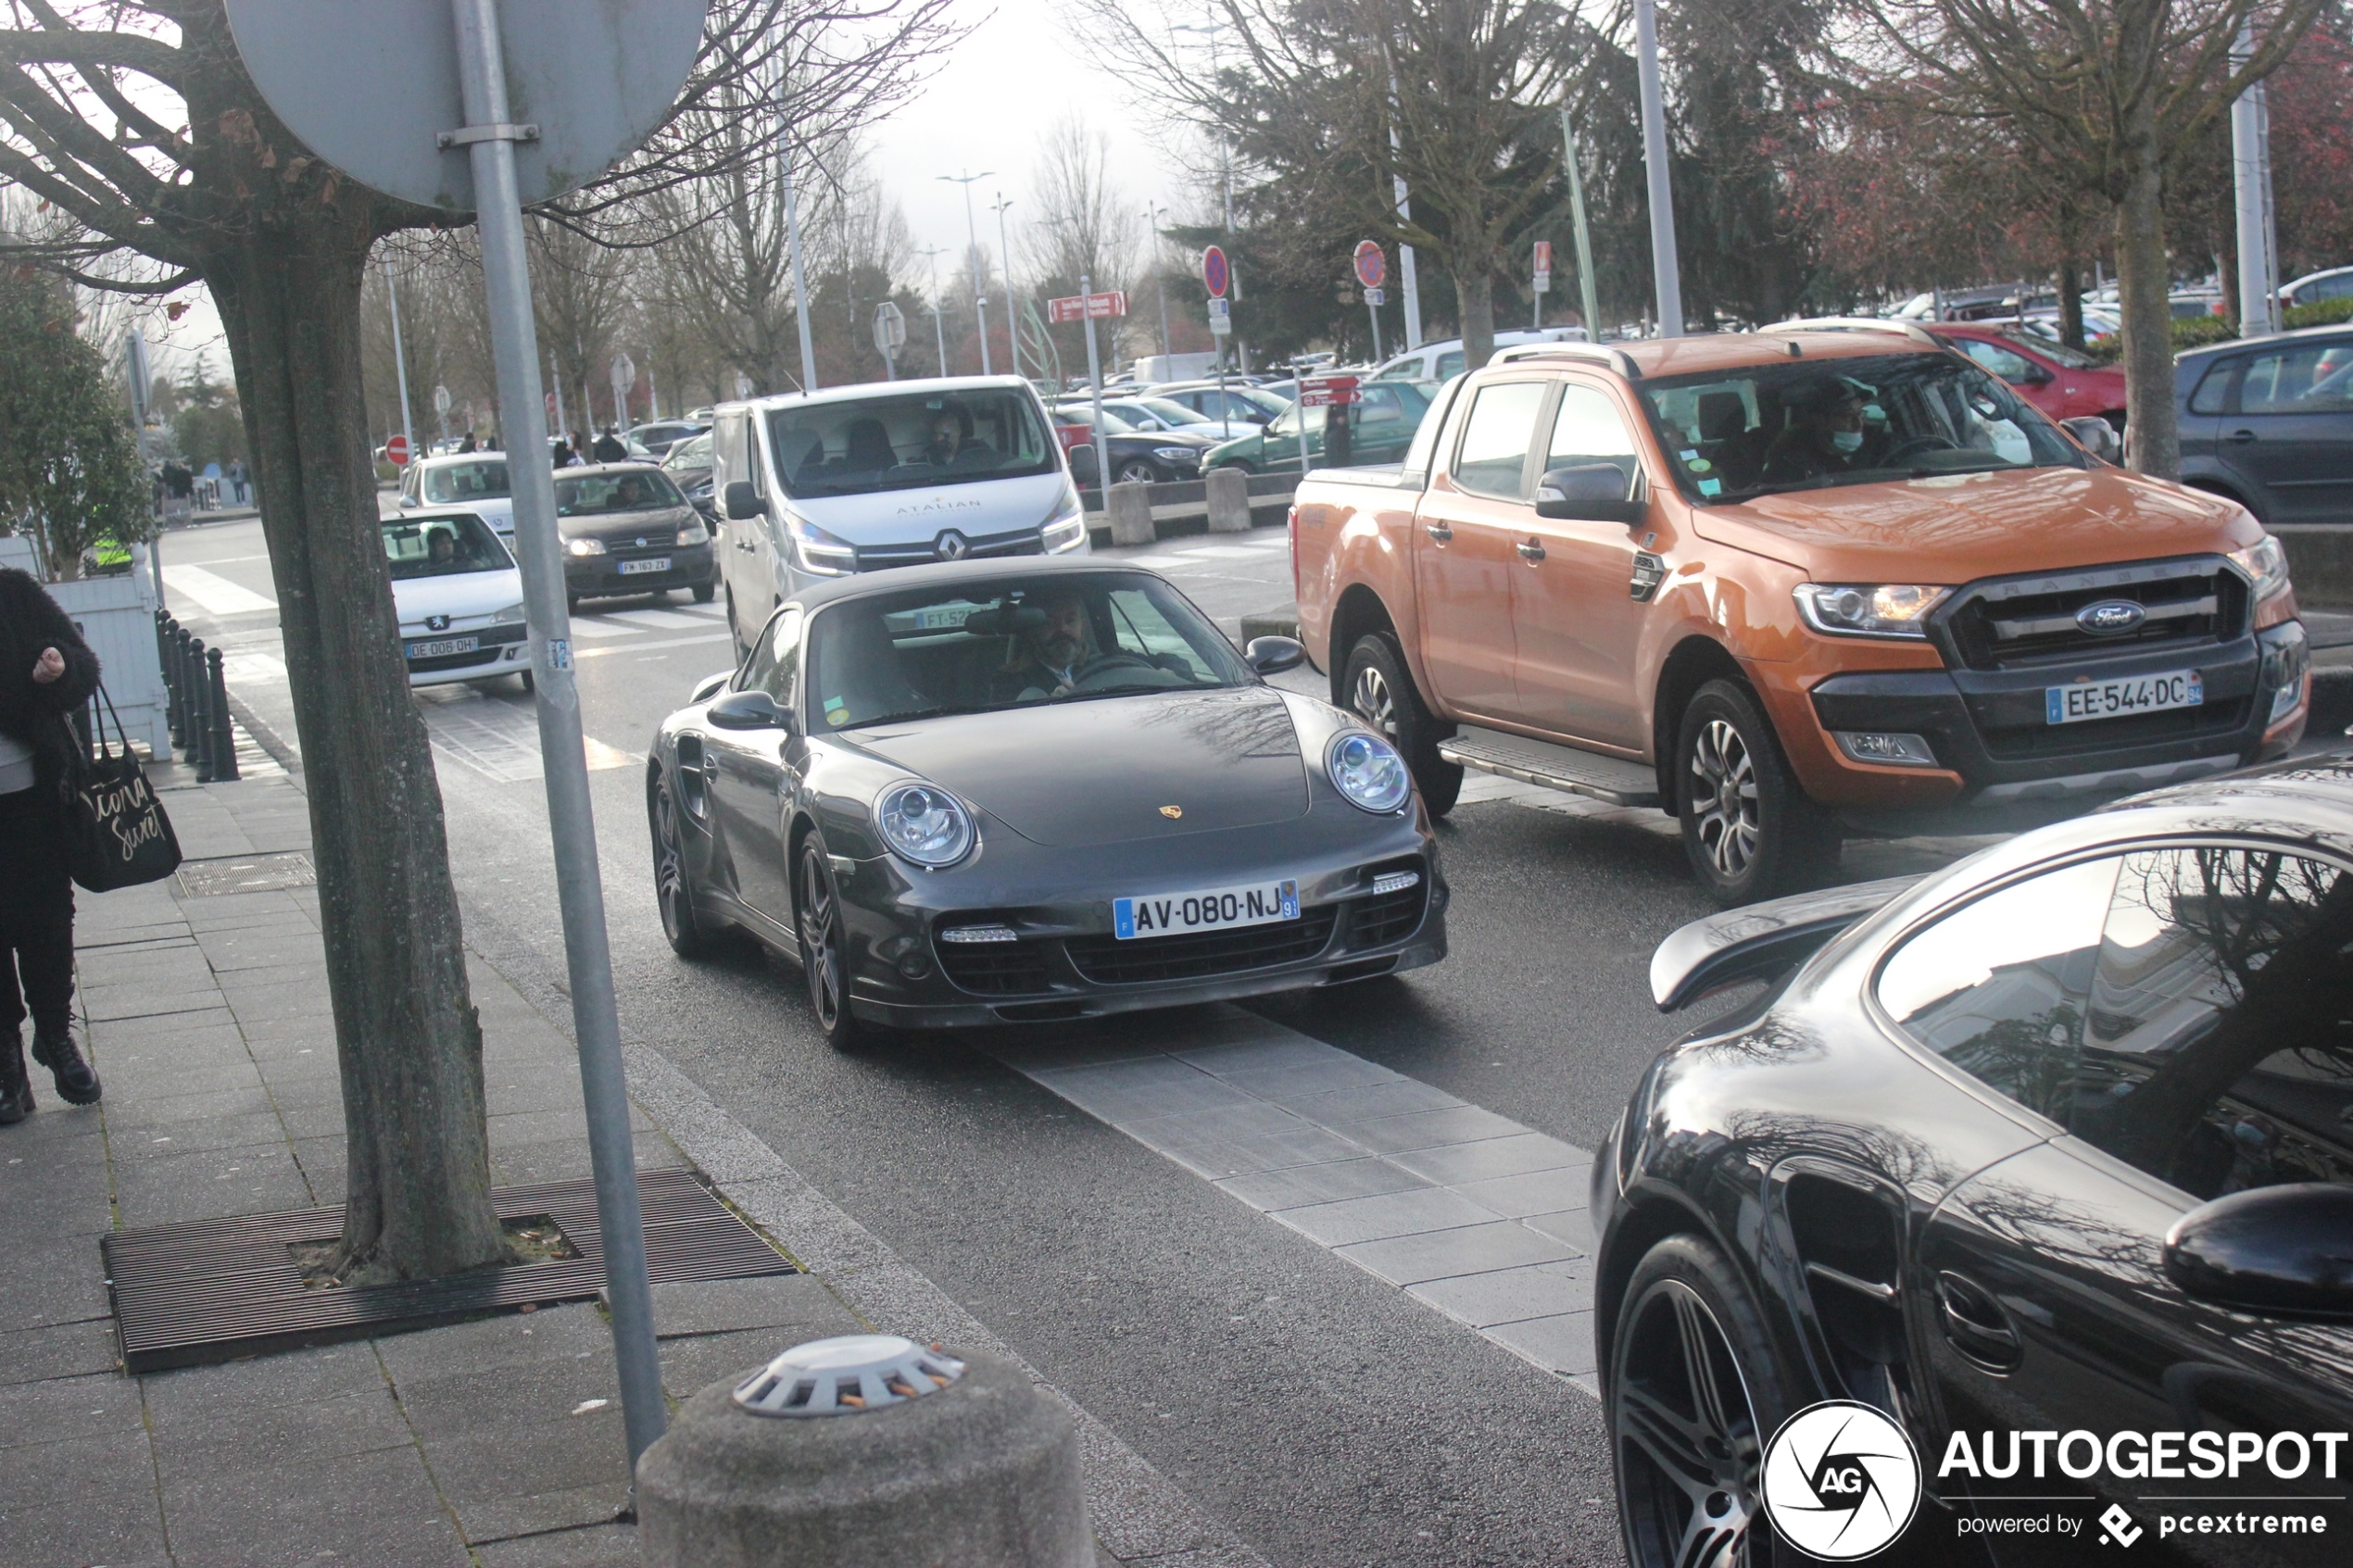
[223,0,706,211]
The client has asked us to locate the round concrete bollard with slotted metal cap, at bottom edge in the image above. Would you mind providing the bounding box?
[637,1333,1097,1568]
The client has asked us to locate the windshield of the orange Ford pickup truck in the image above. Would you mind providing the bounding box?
[1640,353,2084,501]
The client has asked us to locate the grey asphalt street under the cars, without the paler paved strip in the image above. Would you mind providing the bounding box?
[162,521,2353,1568]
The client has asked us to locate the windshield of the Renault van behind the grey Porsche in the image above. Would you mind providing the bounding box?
[767,388,1062,501]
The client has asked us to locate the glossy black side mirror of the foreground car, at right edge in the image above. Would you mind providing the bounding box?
[2165,1183,2353,1319]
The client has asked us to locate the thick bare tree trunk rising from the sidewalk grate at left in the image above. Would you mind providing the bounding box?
[205,215,506,1281]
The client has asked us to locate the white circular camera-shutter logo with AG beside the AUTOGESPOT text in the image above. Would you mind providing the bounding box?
[1757,1399,1920,1563]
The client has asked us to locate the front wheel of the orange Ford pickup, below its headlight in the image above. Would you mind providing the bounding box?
[1675,680,1840,908]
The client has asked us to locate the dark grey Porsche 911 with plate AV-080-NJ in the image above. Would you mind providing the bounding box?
[645,559,1447,1047]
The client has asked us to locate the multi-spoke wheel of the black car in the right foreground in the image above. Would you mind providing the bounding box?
[1607,1236,1788,1568]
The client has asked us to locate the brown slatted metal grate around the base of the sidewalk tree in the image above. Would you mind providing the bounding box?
[99,1171,793,1373]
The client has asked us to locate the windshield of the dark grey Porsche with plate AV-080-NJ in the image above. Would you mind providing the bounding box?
[807,571,1252,731]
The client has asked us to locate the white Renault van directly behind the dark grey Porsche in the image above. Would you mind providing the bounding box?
[711,376,1087,646]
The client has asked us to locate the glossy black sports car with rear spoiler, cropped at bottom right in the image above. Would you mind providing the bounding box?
[1593,755,2353,1568]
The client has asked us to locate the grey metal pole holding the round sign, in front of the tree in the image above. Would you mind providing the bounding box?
[452,0,668,1495]
